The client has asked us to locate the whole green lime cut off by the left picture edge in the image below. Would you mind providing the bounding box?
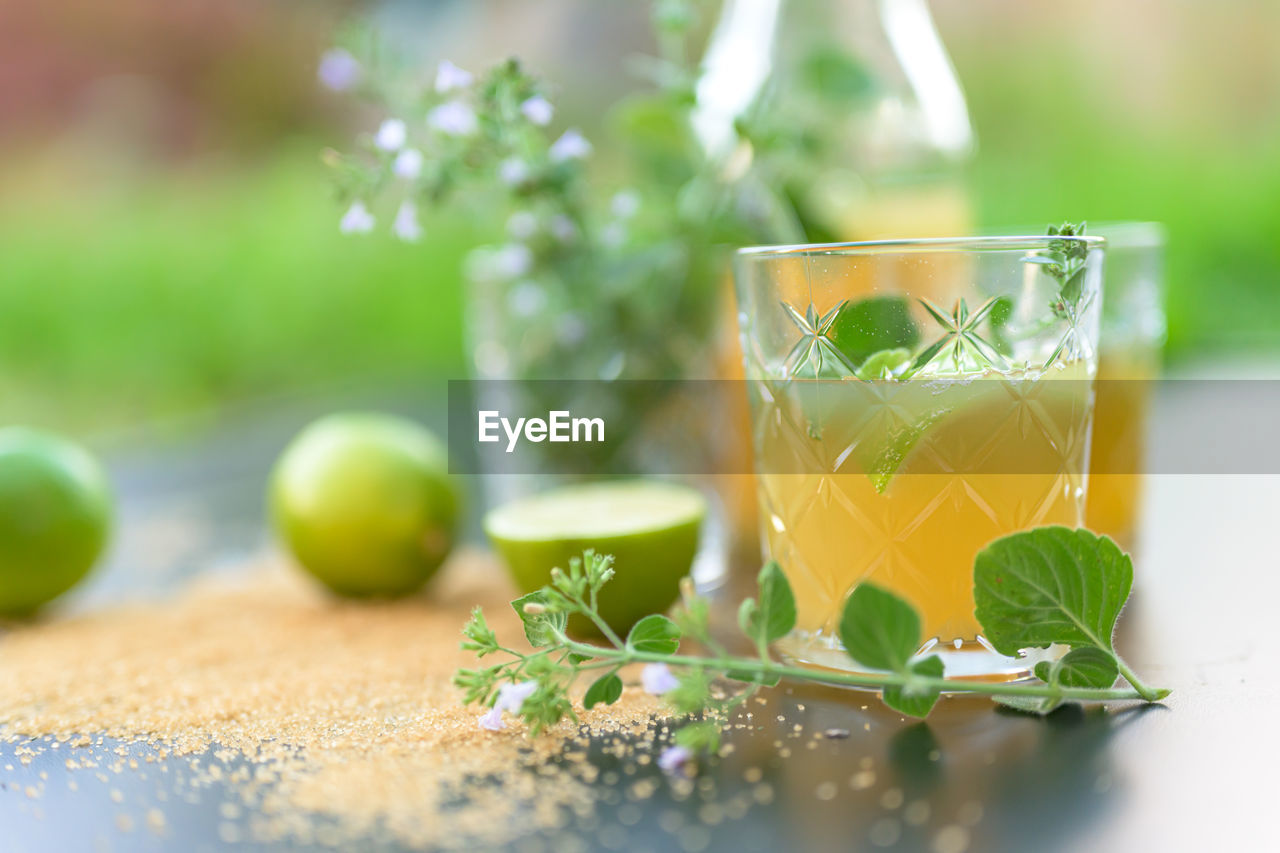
[0,427,111,616]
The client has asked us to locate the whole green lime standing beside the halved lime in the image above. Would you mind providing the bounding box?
[270,414,461,598]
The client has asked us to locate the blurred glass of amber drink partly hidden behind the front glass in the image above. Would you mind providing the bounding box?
[1085,222,1165,553]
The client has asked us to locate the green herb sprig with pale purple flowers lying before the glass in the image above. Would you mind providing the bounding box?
[454,526,1169,766]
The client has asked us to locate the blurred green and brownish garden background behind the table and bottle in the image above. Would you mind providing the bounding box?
[0,0,1280,433]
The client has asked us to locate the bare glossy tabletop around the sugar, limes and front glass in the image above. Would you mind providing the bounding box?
[0,379,1280,853]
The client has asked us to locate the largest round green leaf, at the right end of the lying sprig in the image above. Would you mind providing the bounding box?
[973,526,1133,656]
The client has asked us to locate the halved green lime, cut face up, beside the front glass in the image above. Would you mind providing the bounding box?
[484,480,707,634]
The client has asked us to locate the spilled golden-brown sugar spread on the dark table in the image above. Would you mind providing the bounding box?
[0,552,662,847]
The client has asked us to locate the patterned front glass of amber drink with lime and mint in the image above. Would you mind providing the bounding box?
[735,236,1103,678]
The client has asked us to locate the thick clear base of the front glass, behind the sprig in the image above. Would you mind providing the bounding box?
[776,631,1066,689]
